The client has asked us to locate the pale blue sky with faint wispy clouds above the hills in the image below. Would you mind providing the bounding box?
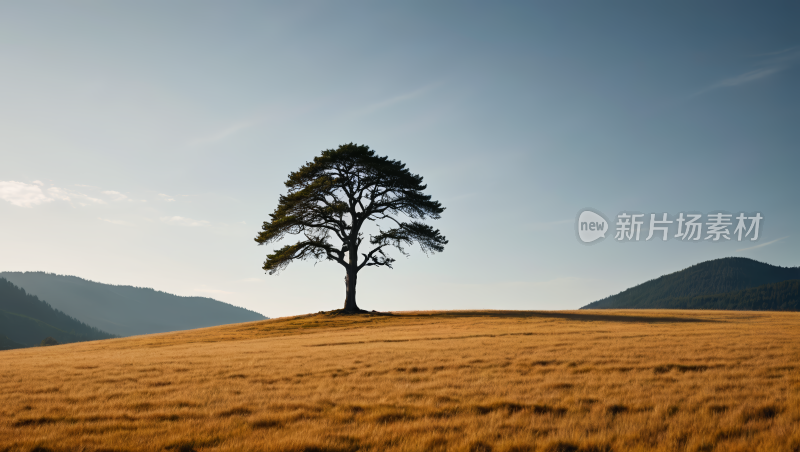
[0,0,800,317]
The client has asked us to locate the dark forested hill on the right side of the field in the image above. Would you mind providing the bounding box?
[581,257,800,311]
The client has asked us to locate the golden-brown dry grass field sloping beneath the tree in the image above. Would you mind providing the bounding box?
[0,311,800,452]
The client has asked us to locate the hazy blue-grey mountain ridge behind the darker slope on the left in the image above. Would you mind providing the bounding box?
[0,272,266,343]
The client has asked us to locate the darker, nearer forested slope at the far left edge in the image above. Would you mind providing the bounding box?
[0,278,114,350]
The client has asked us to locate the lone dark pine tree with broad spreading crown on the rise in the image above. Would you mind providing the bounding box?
[255,143,447,312]
